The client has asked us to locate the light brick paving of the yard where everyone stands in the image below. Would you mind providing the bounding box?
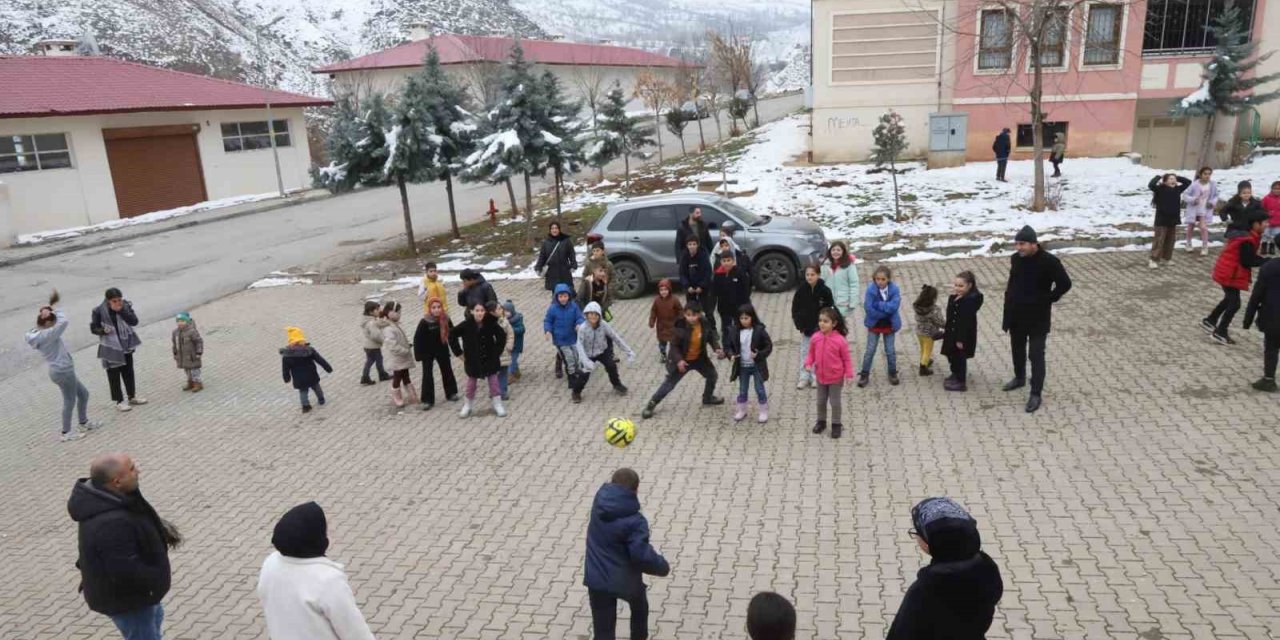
[0,253,1280,640]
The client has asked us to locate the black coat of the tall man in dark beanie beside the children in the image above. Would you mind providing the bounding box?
[1001,248,1071,335]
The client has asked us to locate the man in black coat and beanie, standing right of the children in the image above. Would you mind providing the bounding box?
[1004,227,1071,413]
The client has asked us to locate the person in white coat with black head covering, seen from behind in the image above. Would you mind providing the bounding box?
[257,502,374,640]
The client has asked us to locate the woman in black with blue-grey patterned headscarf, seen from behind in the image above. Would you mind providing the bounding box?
[886,498,1005,640]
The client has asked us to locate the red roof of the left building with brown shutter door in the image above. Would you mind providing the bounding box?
[0,55,333,118]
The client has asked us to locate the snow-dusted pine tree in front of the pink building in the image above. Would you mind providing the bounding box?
[1170,3,1280,166]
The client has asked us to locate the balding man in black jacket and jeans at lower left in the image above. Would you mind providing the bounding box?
[67,453,182,640]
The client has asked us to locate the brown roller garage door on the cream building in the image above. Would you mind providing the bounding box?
[102,124,207,218]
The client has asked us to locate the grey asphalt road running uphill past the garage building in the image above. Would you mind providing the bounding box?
[0,95,803,379]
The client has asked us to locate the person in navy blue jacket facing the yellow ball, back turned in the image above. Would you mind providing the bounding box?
[582,468,671,640]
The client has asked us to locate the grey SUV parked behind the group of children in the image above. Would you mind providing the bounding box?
[588,192,827,298]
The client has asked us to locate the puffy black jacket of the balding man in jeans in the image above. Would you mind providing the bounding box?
[67,477,172,616]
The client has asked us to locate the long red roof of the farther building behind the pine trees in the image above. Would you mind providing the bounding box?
[315,33,684,73]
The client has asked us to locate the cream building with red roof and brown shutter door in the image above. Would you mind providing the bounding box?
[0,51,330,243]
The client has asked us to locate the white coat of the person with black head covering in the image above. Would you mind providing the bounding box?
[257,552,374,640]
